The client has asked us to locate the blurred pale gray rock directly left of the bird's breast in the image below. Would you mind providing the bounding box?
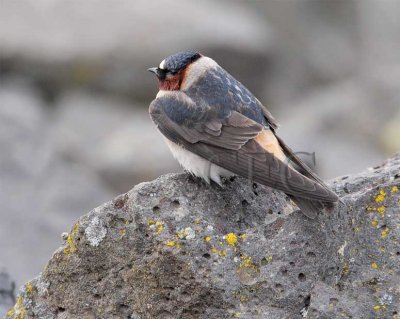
[54,92,180,193]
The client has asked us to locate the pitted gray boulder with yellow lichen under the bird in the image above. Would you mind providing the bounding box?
[6,155,400,319]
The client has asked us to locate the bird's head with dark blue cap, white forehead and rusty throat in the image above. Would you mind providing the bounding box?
[148,51,202,91]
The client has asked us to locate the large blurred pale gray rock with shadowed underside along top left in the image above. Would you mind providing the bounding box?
[0,0,272,100]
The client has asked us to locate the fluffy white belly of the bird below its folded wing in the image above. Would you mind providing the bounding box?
[165,138,235,186]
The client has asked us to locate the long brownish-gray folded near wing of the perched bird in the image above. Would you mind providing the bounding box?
[150,99,337,202]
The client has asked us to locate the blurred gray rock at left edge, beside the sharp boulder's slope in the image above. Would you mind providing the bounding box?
[0,82,115,284]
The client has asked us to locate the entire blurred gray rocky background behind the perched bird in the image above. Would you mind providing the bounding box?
[0,0,400,285]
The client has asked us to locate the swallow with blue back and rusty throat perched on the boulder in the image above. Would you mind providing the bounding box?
[148,51,338,219]
